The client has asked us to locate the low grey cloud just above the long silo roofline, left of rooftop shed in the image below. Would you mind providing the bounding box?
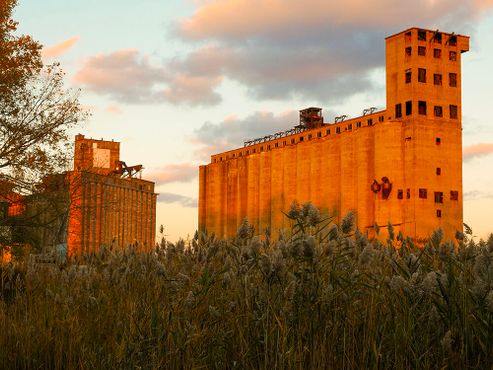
[191,111,340,161]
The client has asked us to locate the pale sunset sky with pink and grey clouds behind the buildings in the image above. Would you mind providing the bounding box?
[14,0,493,240]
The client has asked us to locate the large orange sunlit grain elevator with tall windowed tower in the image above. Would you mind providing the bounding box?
[199,28,469,241]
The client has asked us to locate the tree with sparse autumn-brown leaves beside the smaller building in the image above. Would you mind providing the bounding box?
[0,0,87,254]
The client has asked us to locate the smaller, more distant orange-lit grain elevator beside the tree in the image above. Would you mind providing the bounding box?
[66,135,156,255]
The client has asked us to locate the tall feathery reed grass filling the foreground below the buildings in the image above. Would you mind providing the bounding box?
[0,205,493,369]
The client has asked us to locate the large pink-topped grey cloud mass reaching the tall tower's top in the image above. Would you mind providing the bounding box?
[168,0,493,103]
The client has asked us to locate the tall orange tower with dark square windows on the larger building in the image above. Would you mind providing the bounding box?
[386,28,469,238]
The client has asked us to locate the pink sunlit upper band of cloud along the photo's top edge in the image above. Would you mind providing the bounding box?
[180,0,493,39]
